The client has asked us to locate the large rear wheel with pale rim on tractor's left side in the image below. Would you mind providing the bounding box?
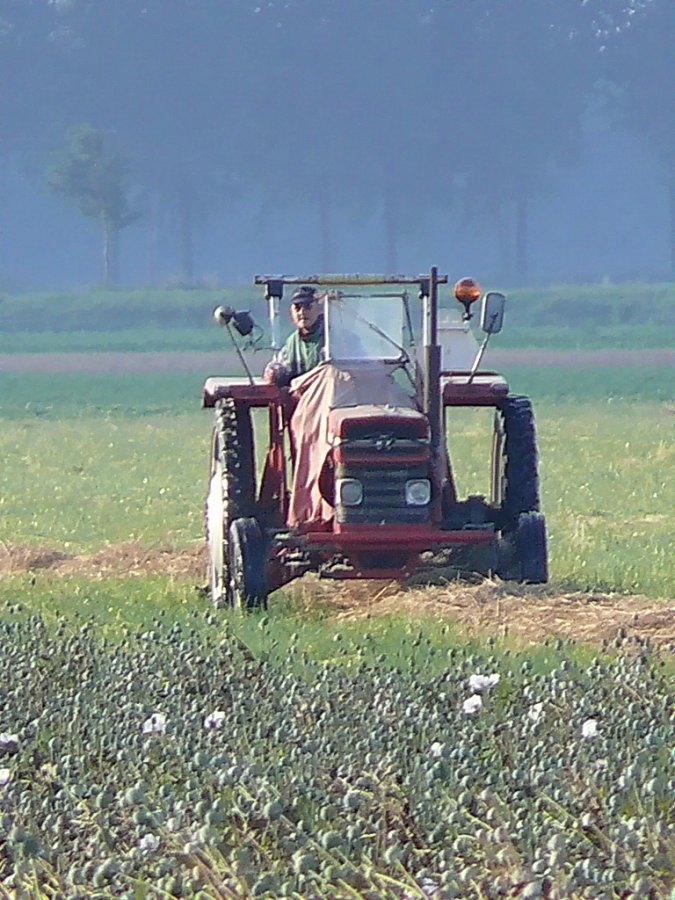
[205,400,255,607]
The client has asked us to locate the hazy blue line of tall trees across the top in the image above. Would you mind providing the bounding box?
[0,0,675,284]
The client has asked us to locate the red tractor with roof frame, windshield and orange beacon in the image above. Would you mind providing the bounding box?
[203,267,548,608]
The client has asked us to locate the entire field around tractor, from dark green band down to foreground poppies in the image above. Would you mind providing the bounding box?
[0,344,675,900]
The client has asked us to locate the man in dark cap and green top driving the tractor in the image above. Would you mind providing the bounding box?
[263,285,324,387]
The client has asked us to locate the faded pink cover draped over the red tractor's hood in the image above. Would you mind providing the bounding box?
[288,360,420,529]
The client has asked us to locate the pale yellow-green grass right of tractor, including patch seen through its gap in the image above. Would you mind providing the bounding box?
[452,399,675,597]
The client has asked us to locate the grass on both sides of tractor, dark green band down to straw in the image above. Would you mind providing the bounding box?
[0,369,675,597]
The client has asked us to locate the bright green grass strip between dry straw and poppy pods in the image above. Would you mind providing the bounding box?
[0,573,632,681]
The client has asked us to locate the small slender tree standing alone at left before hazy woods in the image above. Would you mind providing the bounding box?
[47,125,140,286]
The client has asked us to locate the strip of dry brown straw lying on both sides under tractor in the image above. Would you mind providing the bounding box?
[0,542,675,652]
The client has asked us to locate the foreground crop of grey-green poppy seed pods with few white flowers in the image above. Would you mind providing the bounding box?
[0,604,675,900]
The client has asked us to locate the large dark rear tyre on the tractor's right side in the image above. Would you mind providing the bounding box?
[492,395,539,531]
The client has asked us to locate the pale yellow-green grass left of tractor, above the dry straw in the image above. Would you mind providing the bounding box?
[0,413,209,551]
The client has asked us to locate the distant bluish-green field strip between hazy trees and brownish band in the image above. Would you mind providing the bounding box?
[0,284,675,353]
